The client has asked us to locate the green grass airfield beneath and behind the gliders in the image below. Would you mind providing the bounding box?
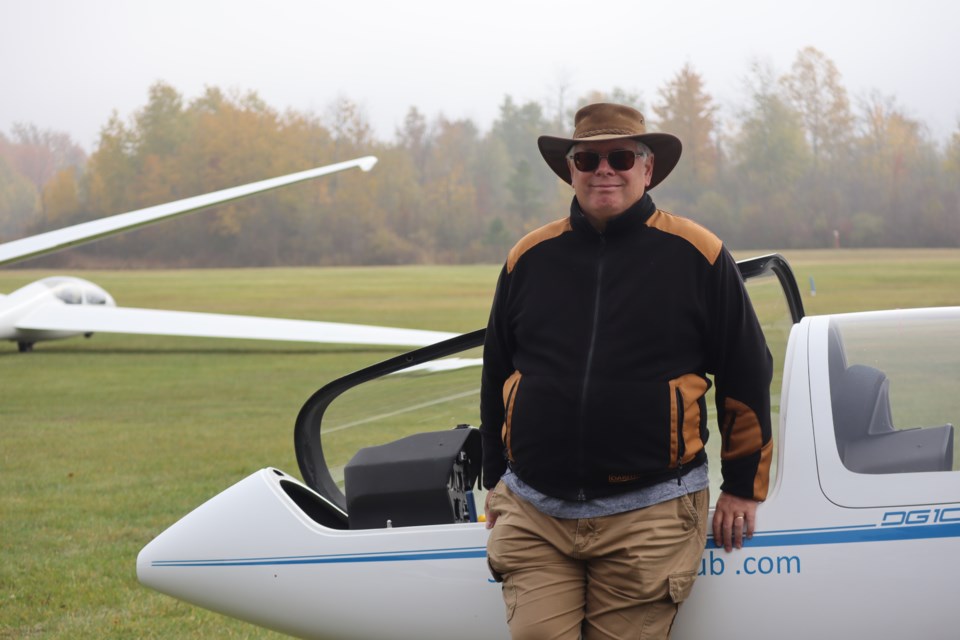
[0,250,960,639]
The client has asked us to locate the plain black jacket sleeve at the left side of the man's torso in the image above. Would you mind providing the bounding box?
[480,266,513,489]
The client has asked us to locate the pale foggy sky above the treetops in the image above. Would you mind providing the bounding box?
[0,0,960,151]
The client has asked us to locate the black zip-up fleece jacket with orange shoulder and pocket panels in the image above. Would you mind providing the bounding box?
[480,195,772,500]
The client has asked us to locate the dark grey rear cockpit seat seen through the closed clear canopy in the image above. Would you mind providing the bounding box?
[831,362,953,473]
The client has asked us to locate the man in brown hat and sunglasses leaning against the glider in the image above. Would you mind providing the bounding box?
[481,104,772,640]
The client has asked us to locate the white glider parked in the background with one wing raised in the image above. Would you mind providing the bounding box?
[0,156,456,351]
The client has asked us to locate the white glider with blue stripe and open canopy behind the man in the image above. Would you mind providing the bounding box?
[137,256,960,640]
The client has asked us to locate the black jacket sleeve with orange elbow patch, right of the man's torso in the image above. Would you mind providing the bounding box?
[709,247,773,501]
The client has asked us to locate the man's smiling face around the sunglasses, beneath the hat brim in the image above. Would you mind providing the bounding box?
[567,140,653,230]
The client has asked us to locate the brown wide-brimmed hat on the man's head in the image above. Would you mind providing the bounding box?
[537,102,683,189]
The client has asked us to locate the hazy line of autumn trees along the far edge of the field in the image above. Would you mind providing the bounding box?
[0,48,960,266]
